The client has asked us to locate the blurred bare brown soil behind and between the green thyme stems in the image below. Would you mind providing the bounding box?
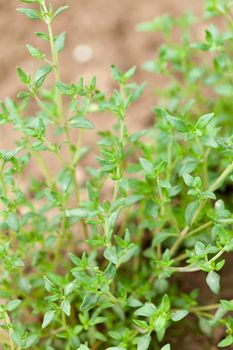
[0,0,232,350]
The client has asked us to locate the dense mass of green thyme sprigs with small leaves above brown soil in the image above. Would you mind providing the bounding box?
[0,0,233,350]
